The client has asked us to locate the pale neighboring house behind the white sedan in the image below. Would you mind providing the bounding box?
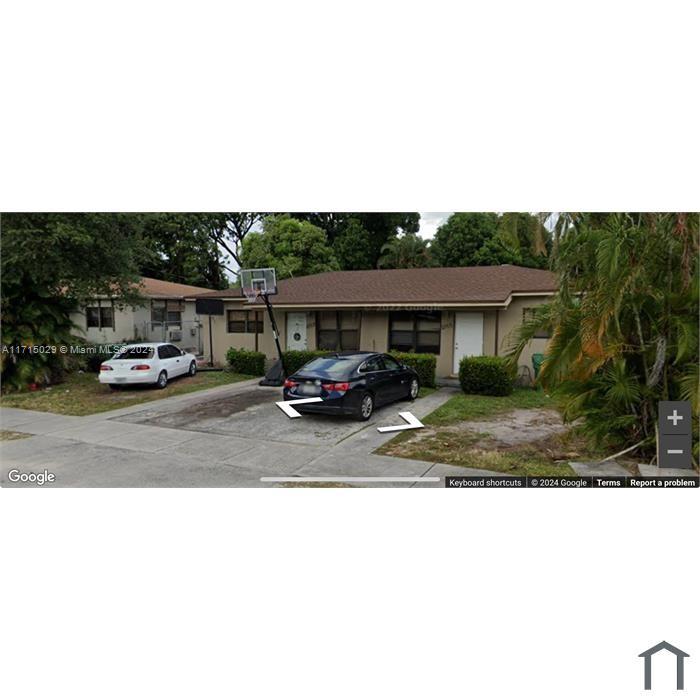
[71,277,219,354]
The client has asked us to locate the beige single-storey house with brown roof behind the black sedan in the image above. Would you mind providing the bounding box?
[198,265,556,378]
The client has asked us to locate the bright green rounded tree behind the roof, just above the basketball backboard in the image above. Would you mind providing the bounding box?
[241,215,340,279]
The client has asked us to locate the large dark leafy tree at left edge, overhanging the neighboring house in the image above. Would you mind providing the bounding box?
[0,214,145,389]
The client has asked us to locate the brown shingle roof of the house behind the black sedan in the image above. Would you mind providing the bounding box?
[198,265,557,306]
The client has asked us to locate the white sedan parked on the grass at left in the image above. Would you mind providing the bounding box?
[98,343,197,389]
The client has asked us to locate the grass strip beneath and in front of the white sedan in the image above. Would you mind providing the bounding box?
[0,370,252,416]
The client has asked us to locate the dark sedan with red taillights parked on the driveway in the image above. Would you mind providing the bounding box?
[284,352,420,420]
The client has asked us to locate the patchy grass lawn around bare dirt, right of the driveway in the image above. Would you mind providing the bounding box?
[377,389,586,477]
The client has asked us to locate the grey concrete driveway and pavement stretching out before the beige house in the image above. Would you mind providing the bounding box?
[0,380,476,488]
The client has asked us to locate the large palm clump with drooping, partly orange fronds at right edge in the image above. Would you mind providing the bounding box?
[510,213,700,459]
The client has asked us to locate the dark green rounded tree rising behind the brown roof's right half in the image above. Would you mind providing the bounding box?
[431,212,498,267]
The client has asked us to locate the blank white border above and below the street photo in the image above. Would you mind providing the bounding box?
[0,0,700,700]
